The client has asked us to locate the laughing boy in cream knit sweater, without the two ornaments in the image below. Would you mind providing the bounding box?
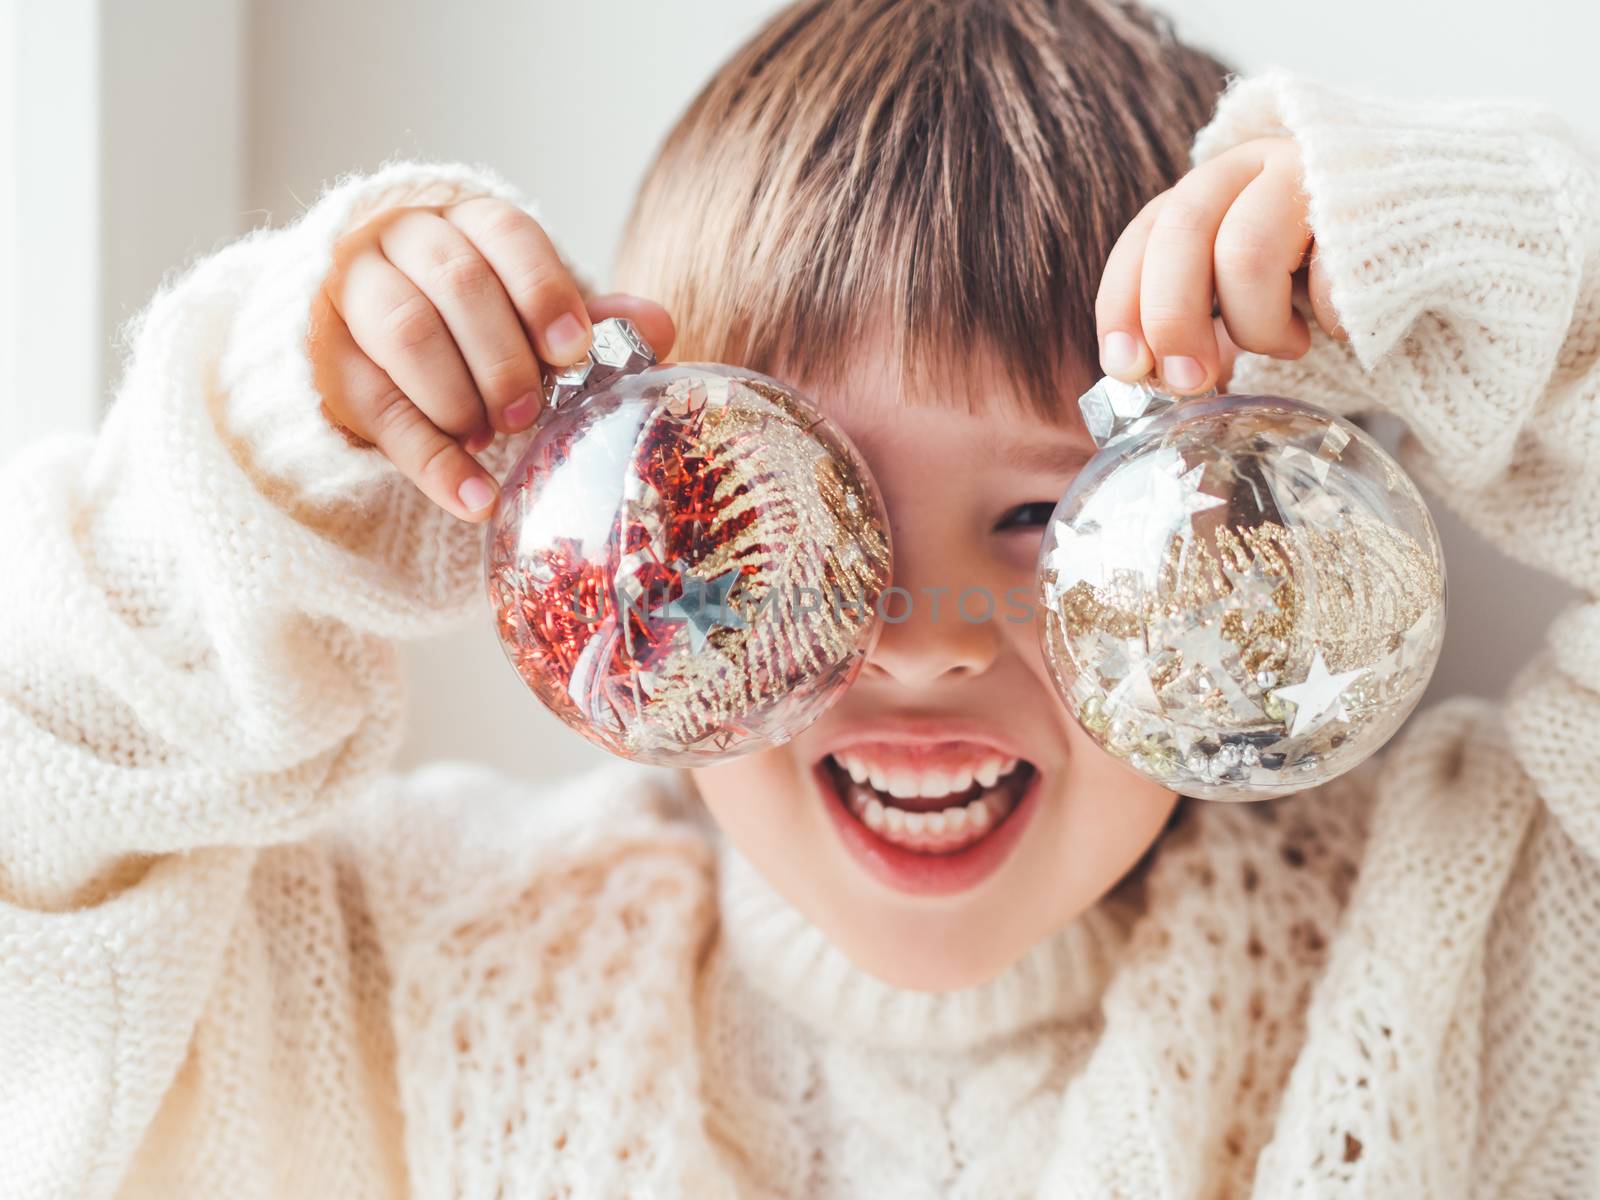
[0,0,1600,1198]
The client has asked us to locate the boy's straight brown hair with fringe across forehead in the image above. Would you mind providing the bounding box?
[616,0,1227,416]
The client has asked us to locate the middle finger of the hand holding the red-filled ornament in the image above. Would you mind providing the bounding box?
[378,210,539,434]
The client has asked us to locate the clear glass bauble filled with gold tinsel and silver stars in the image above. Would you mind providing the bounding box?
[1038,378,1445,800]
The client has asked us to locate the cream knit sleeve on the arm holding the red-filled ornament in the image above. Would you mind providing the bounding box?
[0,162,544,1195]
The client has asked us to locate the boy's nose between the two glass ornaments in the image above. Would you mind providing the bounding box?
[861,581,1000,688]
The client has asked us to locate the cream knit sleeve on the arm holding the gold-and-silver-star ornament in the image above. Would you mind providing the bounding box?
[1192,70,1600,862]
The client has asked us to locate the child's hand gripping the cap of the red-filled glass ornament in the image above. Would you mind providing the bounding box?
[310,197,674,522]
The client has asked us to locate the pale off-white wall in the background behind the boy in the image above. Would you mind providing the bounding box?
[0,0,1600,784]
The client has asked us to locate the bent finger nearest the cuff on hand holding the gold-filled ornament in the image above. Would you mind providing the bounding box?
[1213,170,1310,358]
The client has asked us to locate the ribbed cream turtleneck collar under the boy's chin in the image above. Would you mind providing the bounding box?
[715,834,1131,1050]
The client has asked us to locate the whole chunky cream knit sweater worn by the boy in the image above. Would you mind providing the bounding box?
[0,72,1600,1200]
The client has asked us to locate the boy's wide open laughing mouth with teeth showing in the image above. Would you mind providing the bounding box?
[816,742,1040,893]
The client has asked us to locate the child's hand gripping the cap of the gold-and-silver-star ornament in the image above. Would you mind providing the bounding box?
[1094,138,1346,392]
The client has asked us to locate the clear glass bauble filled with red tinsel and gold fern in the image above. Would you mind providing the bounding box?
[485,318,890,766]
